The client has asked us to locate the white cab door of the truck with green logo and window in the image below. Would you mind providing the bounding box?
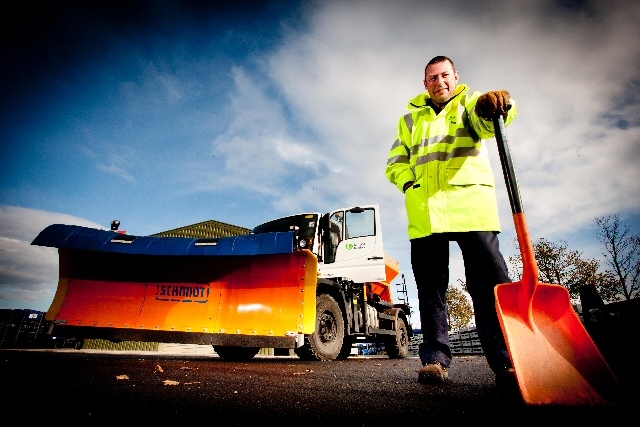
[321,205,385,283]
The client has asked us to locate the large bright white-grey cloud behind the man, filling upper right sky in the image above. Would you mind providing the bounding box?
[258,1,640,324]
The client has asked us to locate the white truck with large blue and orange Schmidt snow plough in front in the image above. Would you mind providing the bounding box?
[32,205,413,360]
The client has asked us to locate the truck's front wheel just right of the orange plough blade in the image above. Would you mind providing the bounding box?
[295,294,344,360]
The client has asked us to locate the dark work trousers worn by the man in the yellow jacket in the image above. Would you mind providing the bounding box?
[411,231,512,373]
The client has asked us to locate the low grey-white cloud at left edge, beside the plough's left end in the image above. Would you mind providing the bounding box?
[0,205,101,311]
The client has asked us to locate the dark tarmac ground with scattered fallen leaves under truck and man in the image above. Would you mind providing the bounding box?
[0,349,639,426]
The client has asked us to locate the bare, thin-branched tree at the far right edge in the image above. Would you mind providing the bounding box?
[594,215,640,300]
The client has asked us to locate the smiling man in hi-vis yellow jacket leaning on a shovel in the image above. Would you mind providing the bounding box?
[386,56,517,387]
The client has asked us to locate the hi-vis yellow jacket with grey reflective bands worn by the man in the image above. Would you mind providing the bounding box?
[386,84,517,239]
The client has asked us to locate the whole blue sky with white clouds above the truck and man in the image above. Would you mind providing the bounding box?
[0,0,640,324]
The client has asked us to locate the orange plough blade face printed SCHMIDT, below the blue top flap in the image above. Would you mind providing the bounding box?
[47,249,318,341]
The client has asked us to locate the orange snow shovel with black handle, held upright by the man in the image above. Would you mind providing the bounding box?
[493,116,622,406]
